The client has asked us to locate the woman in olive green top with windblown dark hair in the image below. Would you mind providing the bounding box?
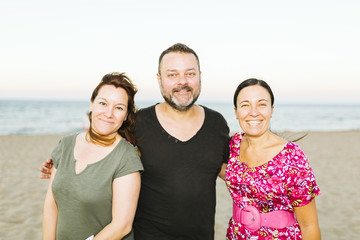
[43,73,143,240]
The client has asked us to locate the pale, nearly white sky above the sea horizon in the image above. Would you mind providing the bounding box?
[0,0,360,104]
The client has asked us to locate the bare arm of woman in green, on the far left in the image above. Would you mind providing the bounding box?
[42,168,58,240]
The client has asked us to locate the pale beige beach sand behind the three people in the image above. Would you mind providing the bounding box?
[0,131,360,240]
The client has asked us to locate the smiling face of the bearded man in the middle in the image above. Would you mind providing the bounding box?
[157,52,201,111]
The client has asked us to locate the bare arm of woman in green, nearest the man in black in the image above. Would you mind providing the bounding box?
[94,172,140,240]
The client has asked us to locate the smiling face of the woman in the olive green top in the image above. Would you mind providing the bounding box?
[89,85,128,136]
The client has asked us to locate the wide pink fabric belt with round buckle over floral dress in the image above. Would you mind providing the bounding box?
[233,203,296,232]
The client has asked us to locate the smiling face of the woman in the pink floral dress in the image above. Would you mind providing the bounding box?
[235,85,273,137]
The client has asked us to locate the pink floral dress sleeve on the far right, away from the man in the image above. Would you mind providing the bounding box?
[286,144,321,207]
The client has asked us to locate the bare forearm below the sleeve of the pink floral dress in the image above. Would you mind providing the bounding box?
[294,198,321,240]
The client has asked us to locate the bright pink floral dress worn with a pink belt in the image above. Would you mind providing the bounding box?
[225,133,320,240]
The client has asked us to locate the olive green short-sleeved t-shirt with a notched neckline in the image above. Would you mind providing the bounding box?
[51,134,143,240]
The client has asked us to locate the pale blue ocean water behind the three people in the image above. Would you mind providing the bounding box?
[0,100,360,135]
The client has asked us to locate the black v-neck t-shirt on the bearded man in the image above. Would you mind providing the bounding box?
[134,106,229,240]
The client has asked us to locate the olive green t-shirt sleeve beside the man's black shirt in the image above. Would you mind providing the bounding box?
[114,144,144,179]
